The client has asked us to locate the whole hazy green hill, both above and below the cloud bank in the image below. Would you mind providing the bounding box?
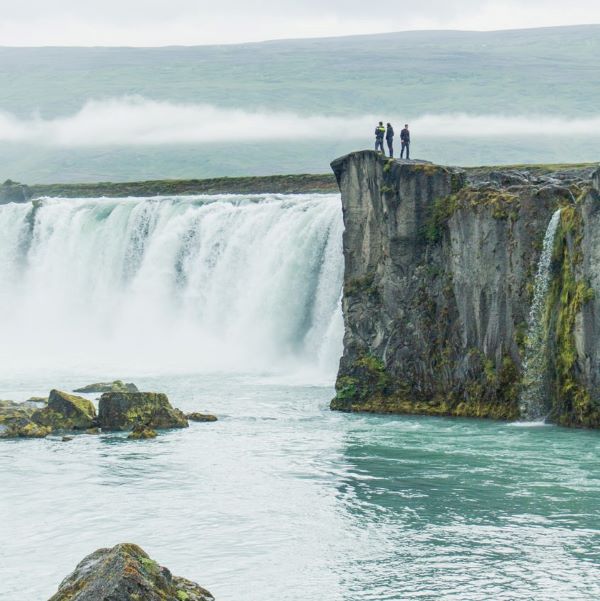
[0,26,600,181]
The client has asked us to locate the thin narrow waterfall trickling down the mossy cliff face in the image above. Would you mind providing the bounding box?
[520,209,561,421]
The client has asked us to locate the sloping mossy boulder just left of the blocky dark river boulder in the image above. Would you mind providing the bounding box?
[31,390,96,431]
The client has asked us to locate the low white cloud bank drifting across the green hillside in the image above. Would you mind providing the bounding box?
[0,97,600,147]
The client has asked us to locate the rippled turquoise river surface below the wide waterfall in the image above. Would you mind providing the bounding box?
[0,375,600,601]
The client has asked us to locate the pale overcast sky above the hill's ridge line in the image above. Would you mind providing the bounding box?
[0,0,600,46]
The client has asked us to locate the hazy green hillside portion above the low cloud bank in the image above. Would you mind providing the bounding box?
[0,25,600,117]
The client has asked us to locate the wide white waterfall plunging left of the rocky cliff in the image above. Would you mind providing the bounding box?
[0,194,343,376]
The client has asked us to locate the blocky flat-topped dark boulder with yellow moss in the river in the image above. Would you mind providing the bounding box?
[98,392,189,431]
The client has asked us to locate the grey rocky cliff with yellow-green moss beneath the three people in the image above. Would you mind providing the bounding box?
[332,151,600,426]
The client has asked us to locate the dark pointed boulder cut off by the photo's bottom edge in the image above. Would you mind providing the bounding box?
[50,543,214,601]
